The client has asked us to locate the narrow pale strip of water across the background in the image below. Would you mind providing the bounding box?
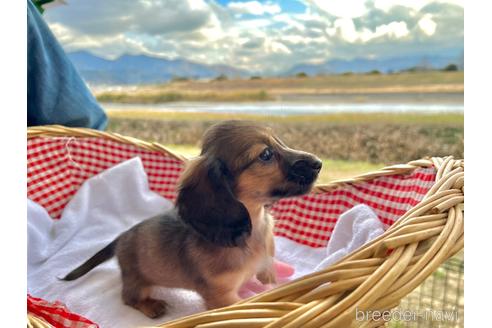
[103,102,464,116]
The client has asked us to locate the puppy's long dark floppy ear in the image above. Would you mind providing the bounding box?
[176,156,251,247]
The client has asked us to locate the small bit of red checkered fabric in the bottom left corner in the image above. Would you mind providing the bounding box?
[27,294,99,328]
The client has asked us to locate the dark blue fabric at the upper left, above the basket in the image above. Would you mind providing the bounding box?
[27,0,108,130]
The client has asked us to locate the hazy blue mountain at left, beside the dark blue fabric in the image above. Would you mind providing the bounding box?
[68,51,250,85]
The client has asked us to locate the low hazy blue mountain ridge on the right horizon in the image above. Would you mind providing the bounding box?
[283,55,462,76]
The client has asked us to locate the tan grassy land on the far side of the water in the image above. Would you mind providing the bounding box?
[94,71,464,103]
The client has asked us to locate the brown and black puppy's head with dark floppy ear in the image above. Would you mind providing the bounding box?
[177,121,321,246]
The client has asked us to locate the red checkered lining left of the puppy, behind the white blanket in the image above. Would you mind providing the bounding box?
[27,137,184,219]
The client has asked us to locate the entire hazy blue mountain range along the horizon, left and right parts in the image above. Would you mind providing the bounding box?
[68,51,463,85]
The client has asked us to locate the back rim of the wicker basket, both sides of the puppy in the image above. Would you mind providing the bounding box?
[27,125,443,194]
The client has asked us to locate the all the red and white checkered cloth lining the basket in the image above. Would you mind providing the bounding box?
[27,137,435,327]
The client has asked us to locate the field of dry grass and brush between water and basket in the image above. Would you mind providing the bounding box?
[108,111,464,165]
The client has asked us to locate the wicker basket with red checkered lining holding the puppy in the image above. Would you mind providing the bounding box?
[27,126,464,328]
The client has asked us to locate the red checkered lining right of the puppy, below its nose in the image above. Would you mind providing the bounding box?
[271,168,435,247]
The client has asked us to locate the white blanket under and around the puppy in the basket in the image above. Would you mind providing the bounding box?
[28,158,382,328]
